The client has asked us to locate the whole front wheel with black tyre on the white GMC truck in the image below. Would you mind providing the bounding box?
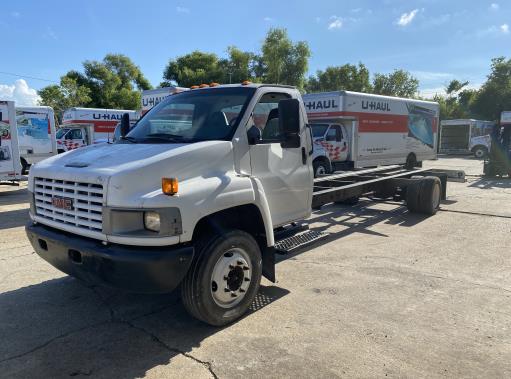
[181,230,262,326]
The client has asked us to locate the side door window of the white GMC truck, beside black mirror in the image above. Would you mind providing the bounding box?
[253,93,289,143]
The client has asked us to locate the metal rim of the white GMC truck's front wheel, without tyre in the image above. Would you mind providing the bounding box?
[210,247,252,308]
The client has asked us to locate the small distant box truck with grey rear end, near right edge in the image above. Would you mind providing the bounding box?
[439,119,495,158]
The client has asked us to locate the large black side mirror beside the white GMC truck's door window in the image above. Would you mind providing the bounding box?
[279,99,300,148]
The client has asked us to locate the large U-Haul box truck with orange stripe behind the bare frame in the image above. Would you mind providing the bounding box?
[303,91,439,176]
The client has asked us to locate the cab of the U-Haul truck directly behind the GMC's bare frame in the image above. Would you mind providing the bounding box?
[310,121,350,177]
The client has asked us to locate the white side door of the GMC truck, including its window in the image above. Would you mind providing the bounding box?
[247,93,313,227]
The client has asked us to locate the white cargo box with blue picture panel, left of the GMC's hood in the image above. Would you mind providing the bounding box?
[16,106,57,170]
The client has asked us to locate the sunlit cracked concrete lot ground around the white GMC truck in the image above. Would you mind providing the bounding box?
[0,158,511,378]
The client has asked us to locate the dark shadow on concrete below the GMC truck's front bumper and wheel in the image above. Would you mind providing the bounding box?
[0,277,289,378]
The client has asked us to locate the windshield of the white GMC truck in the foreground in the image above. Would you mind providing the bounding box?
[126,87,255,143]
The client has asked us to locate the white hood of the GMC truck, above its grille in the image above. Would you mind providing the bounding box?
[30,141,233,188]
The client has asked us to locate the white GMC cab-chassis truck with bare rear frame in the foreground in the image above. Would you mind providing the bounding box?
[26,83,446,325]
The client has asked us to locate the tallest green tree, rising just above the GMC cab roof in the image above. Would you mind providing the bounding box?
[255,29,311,88]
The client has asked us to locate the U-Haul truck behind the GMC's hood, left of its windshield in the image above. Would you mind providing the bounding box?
[57,108,138,153]
